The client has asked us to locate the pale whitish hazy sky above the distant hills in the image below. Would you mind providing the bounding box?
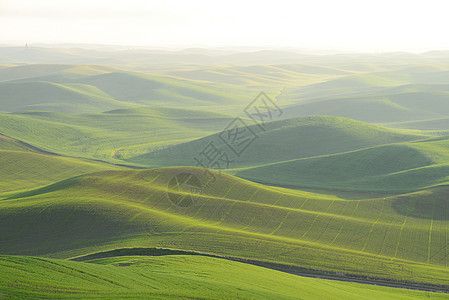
[0,0,449,51]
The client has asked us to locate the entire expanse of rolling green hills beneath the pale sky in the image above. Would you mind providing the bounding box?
[0,47,449,299]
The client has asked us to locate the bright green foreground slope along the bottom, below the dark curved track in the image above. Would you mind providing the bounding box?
[0,255,446,299]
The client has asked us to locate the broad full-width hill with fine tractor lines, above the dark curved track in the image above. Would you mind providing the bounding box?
[0,168,449,284]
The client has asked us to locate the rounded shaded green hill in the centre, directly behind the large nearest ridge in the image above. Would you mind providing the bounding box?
[130,116,423,169]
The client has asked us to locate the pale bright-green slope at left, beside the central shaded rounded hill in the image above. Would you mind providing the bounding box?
[0,108,236,161]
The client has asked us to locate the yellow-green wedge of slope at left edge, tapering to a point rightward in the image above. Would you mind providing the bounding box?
[0,149,121,195]
